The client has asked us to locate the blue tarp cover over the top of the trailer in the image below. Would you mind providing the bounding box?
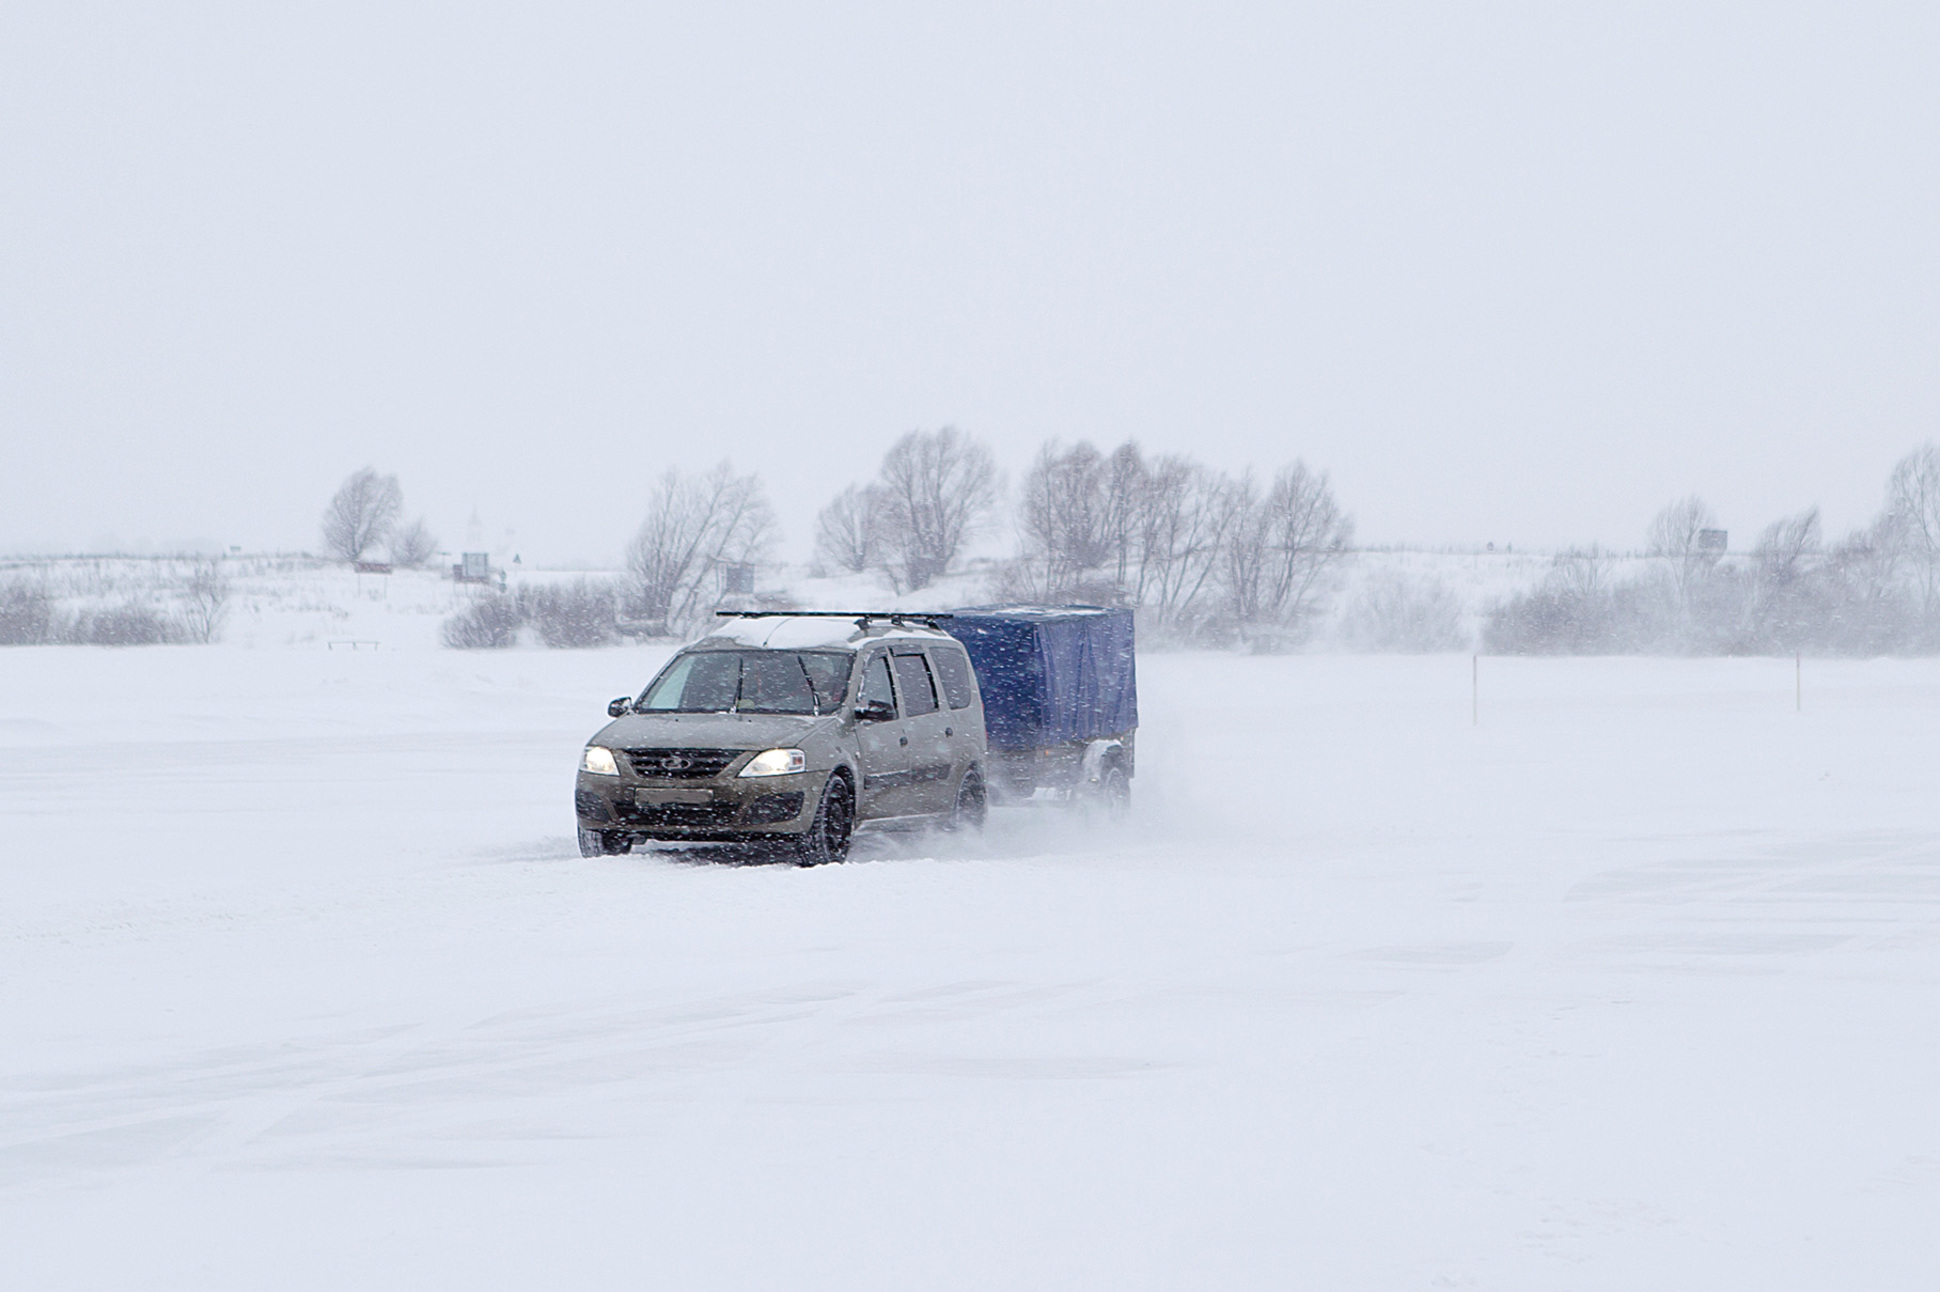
[943,605,1139,749]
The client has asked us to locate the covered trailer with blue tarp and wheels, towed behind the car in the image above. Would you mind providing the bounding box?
[937,605,1139,811]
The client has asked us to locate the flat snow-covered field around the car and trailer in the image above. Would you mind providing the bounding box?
[0,640,1940,1292]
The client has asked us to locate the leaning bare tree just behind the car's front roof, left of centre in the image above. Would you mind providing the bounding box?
[627,462,774,632]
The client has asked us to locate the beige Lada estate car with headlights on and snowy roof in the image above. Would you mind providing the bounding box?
[572,611,987,865]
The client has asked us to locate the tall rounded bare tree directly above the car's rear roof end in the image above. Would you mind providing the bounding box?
[881,427,997,590]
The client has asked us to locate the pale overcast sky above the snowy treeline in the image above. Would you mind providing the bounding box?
[0,0,1940,563]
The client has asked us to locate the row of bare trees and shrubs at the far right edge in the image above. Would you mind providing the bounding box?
[1484,444,1940,654]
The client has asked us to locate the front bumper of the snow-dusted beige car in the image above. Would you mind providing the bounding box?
[572,772,828,842]
